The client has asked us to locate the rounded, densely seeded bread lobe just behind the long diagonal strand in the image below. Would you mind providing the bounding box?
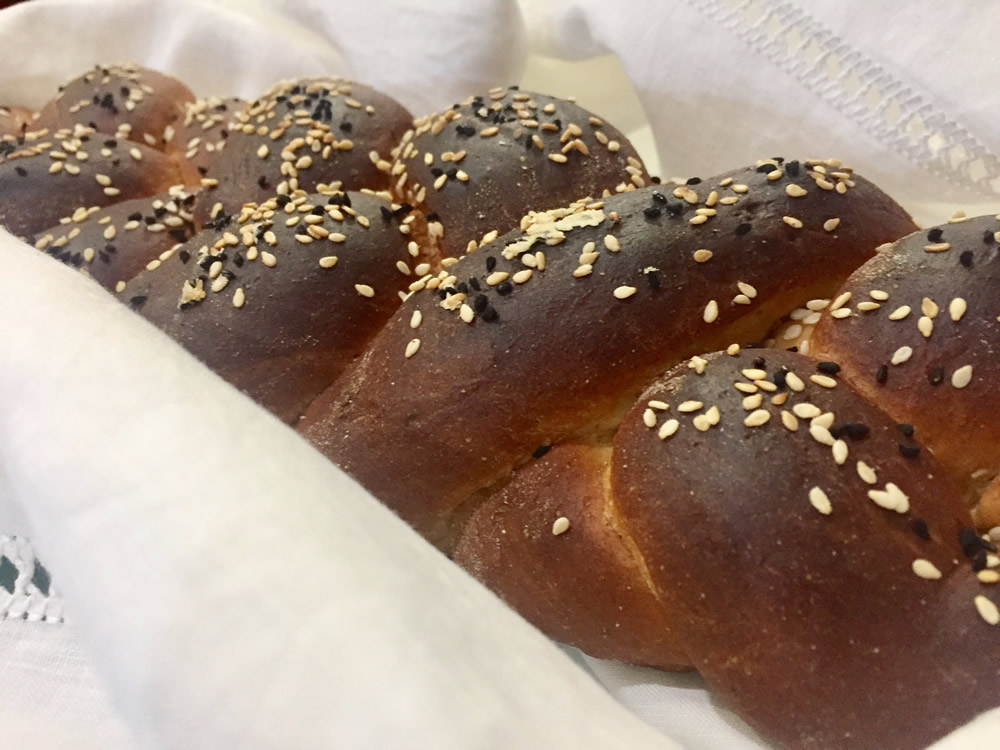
[379,86,650,257]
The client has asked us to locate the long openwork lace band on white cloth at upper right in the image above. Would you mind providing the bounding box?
[689,0,1000,195]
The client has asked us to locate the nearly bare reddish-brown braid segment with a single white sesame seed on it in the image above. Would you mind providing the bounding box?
[455,441,690,669]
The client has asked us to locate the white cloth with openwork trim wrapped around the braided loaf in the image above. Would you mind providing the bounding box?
[0,0,1000,750]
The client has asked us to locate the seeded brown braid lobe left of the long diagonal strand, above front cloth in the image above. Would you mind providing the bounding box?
[119,191,420,422]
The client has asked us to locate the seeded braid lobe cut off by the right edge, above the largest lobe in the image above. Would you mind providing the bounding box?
[810,216,1000,529]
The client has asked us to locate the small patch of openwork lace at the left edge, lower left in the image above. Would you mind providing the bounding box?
[0,535,64,623]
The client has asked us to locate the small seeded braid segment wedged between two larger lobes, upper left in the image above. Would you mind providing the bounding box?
[163,96,247,184]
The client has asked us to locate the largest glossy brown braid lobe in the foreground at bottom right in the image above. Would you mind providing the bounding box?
[612,350,1000,750]
